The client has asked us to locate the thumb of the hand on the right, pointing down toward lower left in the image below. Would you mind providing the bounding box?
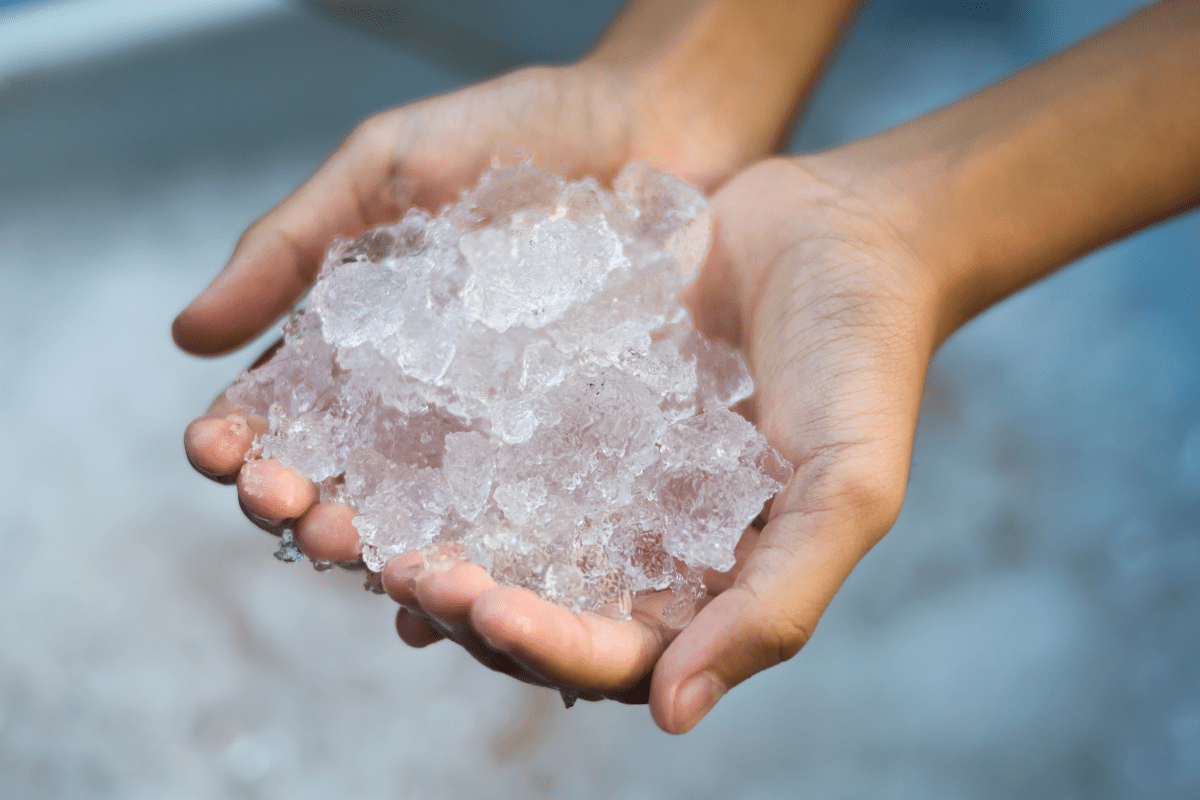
[650,511,874,733]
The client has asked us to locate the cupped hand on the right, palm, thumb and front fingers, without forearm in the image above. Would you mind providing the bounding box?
[300,157,937,733]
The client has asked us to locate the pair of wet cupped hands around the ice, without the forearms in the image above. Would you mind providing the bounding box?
[174,66,940,733]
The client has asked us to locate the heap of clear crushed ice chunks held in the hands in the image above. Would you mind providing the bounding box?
[228,164,792,616]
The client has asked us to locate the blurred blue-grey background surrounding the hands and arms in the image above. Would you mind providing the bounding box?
[0,0,1200,800]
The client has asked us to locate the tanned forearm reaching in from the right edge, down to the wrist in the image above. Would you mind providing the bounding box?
[826,0,1200,338]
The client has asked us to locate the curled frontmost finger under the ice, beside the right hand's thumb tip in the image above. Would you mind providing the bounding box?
[470,587,673,693]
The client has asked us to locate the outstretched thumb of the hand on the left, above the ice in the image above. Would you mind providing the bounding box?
[172,113,404,355]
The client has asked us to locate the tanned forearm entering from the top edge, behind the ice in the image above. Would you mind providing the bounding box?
[586,0,858,183]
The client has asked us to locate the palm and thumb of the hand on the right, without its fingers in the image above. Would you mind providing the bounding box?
[652,160,936,730]
